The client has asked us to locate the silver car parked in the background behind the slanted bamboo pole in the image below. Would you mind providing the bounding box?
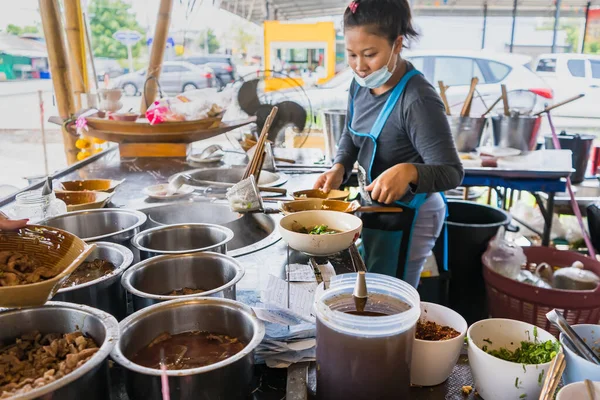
[112,61,214,96]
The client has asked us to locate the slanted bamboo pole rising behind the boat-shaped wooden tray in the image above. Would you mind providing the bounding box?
[140,0,173,114]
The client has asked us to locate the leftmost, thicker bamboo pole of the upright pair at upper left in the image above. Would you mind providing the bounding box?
[39,0,78,165]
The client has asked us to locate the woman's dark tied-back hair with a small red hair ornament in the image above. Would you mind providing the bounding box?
[344,0,419,44]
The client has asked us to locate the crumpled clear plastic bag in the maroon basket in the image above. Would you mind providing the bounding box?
[483,227,527,280]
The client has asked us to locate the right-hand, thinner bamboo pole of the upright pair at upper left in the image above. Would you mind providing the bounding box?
[64,0,88,110]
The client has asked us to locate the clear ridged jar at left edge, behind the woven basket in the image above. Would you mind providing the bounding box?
[9,190,67,224]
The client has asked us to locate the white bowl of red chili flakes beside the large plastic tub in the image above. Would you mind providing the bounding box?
[410,302,467,386]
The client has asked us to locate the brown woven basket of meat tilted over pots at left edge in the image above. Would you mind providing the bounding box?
[0,225,95,307]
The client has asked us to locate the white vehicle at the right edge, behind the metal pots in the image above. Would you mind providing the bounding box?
[534,53,600,118]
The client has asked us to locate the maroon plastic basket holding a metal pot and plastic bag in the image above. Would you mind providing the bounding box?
[483,247,600,336]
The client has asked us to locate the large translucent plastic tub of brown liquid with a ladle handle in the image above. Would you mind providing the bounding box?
[315,273,421,400]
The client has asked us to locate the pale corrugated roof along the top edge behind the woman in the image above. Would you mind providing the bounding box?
[220,0,600,24]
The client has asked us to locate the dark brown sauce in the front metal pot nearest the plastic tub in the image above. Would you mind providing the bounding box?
[131,331,245,370]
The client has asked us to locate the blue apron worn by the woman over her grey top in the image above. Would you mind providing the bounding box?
[347,69,448,279]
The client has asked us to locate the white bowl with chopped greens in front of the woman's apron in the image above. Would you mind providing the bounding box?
[279,210,362,256]
